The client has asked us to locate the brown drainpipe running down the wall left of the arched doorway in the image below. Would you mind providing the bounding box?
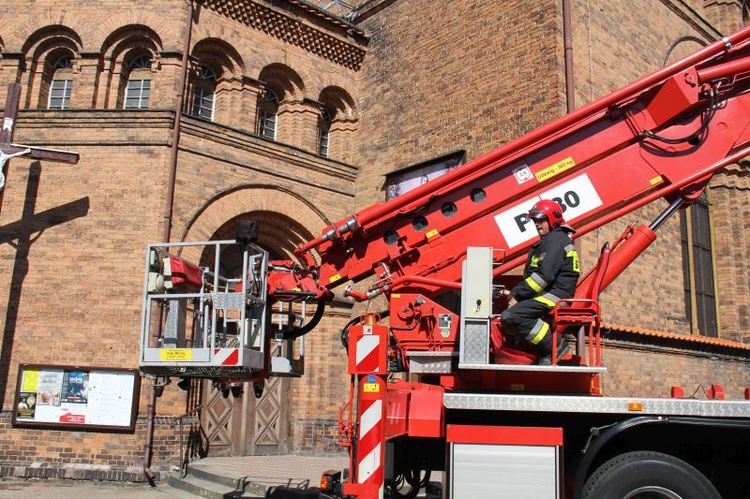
[143,0,193,486]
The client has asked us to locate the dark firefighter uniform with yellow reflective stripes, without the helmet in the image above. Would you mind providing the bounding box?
[501,229,581,356]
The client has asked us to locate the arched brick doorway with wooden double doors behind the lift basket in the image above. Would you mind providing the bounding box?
[184,187,323,456]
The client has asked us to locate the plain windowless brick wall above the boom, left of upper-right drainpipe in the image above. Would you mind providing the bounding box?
[358,0,565,204]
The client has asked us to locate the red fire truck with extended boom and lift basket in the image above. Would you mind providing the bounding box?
[140,22,750,499]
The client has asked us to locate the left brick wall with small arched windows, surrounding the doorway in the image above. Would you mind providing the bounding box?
[0,0,361,468]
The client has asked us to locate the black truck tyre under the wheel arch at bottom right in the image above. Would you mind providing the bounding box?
[582,451,721,499]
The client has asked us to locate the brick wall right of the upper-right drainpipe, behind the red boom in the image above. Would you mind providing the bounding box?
[571,0,748,338]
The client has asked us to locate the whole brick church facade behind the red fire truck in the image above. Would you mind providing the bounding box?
[0,0,750,479]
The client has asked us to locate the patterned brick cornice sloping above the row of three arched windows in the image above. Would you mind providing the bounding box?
[204,0,368,71]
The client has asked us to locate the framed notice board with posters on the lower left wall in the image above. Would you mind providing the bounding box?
[12,364,141,432]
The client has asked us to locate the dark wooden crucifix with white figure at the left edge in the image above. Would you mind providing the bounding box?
[0,83,78,215]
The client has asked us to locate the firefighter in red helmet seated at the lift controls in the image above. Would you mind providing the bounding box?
[500,200,581,365]
